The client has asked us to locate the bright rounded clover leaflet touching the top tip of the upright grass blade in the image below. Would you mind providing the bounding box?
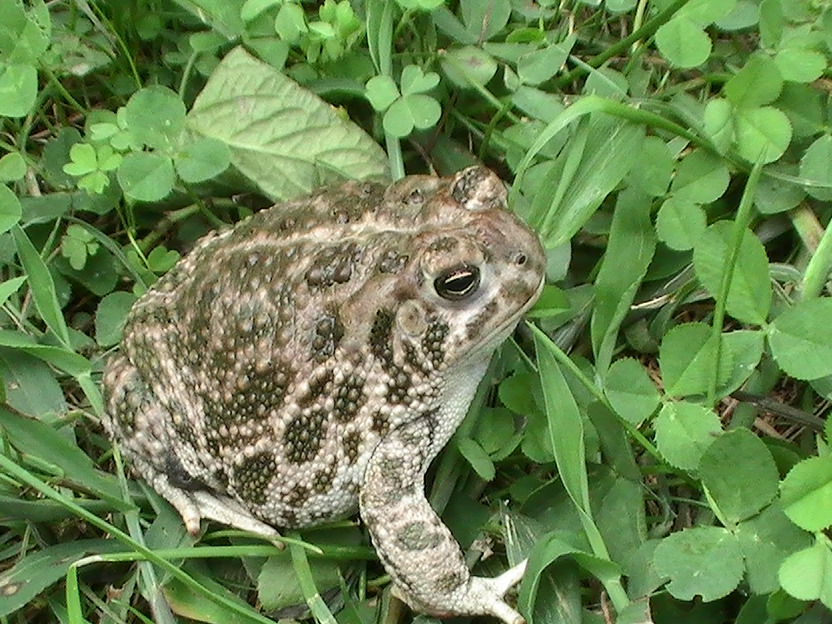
[735,106,792,163]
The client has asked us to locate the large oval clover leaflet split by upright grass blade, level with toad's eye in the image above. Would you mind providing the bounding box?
[693,220,772,325]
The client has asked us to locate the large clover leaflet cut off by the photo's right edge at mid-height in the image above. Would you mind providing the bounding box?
[768,298,832,380]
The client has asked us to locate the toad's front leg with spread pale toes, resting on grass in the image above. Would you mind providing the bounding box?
[359,417,525,624]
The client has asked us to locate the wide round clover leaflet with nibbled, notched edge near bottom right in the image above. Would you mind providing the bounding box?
[653,526,744,602]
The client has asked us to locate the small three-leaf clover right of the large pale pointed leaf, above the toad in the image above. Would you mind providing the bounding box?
[365,65,442,138]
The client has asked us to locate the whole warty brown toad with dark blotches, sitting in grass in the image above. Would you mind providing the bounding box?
[105,167,545,624]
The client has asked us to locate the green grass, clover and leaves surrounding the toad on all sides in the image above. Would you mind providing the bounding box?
[0,0,832,624]
